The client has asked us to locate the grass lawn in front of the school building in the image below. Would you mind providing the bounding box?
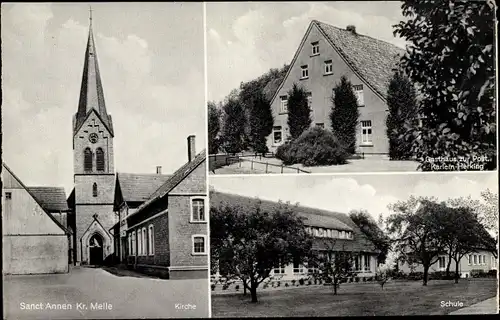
[212,279,497,317]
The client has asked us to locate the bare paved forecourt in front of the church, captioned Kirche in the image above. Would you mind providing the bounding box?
[3,268,209,320]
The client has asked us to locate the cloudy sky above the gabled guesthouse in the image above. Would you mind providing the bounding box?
[206,1,405,101]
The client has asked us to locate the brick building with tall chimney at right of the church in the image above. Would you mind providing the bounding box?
[124,136,208,279]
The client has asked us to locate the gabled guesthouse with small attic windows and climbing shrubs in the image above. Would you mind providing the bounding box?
[264,20,404,154]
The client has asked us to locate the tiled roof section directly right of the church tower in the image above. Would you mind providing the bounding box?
[116,173,172,202]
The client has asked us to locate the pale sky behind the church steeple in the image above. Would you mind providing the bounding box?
[1,3,206,194]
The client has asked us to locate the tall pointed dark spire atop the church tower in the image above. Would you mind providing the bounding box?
[73,8,113,135]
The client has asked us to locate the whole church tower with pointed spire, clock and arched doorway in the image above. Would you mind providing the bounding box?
[73,12,117,265]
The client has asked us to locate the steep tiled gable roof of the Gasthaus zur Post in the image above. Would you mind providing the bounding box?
[271,20,405,106]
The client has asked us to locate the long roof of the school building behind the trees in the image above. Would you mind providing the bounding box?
[210,191,377,252]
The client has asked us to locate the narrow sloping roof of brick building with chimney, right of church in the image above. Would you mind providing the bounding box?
[127,149,207,219]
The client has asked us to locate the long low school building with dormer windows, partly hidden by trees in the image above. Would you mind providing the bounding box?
[210,191,379,280]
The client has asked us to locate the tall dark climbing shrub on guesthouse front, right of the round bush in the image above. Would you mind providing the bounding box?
[330,76,359,154]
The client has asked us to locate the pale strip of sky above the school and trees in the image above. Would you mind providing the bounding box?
[210,172,498,221]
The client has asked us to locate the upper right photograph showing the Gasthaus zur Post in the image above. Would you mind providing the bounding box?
[206,0,497,175]
